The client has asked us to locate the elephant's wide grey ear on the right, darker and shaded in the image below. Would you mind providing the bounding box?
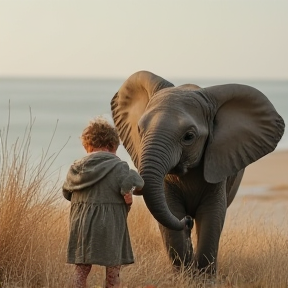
[201,84,285,183]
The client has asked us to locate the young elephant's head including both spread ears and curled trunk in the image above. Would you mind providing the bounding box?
[111,71,285,230]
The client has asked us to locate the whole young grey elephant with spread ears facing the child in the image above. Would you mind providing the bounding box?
[111,71,285,273]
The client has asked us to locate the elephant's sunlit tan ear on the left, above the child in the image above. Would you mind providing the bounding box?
[111,71,174,168]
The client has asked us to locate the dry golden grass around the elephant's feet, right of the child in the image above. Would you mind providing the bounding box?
[122,199,288,288]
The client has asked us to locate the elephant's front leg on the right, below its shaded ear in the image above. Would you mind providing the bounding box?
[195,185,227,274]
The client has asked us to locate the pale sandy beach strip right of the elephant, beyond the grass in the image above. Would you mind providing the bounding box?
[228,151,288,231]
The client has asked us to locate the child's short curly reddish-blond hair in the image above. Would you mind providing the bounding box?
[81,116,120,151]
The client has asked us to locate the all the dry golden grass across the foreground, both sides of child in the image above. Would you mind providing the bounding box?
[0,115,288,288]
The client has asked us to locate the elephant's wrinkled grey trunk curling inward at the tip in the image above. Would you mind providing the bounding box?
[139,138,185,230]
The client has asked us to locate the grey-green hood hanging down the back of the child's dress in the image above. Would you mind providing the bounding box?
[63,151,122,191]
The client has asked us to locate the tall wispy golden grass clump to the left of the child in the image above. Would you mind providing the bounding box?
[0,113,71,287]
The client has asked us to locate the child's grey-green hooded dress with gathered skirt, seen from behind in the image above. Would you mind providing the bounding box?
[63,151,144,266]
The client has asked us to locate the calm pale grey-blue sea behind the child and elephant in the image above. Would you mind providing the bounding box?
[0,79,288,180]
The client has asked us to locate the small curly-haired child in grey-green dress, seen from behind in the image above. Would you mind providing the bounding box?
[63,117,144,288]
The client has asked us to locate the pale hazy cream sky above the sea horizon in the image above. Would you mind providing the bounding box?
[0,0,288,80]
